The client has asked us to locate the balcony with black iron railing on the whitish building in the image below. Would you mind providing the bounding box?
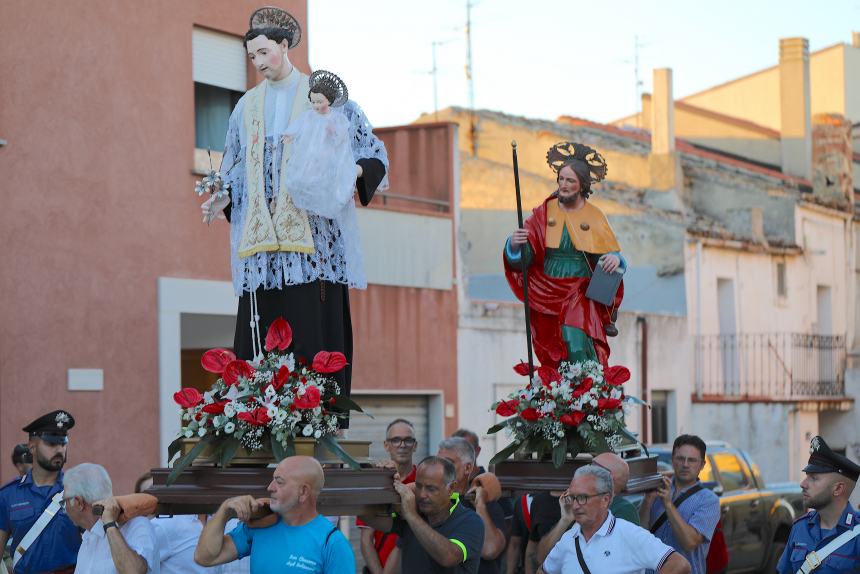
[694,333,846,402]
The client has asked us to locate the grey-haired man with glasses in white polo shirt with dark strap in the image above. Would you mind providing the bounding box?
[541,465,690,574]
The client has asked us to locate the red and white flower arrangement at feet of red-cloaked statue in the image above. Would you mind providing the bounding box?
[488,361,644,467]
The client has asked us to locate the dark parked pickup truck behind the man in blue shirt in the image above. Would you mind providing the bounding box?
[648,441,806,573]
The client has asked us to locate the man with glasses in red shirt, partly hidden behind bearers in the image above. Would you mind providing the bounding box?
[355,419,418,574]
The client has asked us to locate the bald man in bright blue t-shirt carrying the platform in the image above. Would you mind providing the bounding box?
[194,456,355,574]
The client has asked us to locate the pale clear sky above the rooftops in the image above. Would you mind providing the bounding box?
[308,0,860,126]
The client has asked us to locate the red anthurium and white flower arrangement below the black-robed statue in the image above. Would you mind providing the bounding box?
[168,318,361,484]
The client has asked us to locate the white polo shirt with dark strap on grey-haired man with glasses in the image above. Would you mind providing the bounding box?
[543,512,675,574]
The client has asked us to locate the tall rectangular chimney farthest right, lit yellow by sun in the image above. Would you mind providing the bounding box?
[779,38,812,180]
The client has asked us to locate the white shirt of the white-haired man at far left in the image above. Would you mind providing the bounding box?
[75,516,161,574]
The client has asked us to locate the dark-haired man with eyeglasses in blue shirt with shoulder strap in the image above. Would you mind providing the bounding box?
[639,434,720,574]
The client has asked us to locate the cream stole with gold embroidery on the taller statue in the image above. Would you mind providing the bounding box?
[238,74,314,257]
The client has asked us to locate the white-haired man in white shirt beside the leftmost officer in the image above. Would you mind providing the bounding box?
[63,462,161,574]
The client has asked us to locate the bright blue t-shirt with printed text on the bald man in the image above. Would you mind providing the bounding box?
[230,515,355,574]
